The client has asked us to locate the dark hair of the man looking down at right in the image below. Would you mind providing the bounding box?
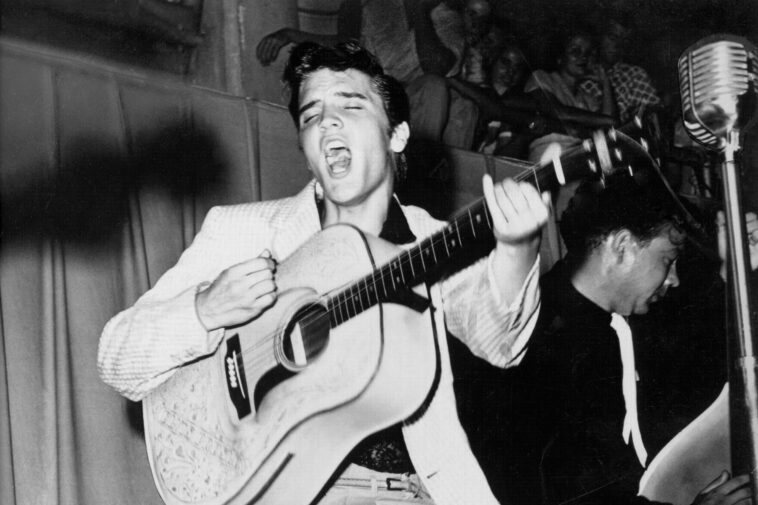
[560,174,684,261]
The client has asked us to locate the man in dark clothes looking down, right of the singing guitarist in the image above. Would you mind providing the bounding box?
[454,177,758,504]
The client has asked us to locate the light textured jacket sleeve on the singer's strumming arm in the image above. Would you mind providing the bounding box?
[97,208,268,401]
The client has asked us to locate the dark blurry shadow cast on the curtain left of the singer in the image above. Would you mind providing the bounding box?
[2,125,227,246]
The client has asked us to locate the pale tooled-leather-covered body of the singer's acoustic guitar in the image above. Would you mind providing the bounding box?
[143,225,438,505]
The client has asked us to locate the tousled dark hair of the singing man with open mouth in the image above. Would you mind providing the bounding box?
[284,42,410,131]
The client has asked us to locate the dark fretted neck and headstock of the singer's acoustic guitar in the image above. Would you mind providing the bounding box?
[327,134,619,327]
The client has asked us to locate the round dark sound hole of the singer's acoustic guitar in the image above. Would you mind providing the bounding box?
[282,305,329,369]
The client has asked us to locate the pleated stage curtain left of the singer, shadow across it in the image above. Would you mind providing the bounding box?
[0,39,309,505]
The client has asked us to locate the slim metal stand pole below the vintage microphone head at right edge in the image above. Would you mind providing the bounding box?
[722,128,758,500]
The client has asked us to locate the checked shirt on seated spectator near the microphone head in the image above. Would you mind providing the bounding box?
[581,62,661,123]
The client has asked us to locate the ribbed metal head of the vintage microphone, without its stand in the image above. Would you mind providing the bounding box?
[678,34,758,150]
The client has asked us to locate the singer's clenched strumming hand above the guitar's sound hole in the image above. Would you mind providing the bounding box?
[195,251,277,331]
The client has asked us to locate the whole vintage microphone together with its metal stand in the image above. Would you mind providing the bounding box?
[678,35,758,492]
